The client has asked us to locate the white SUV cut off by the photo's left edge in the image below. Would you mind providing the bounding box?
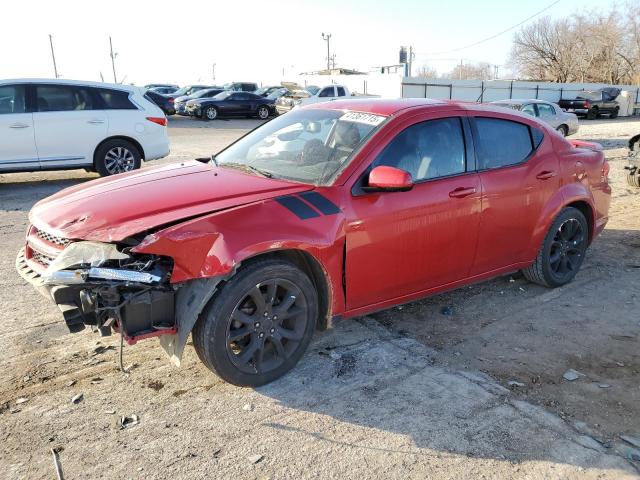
[0,79,169,176]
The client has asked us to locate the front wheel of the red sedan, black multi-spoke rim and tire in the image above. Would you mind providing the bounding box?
[193,260,318,387]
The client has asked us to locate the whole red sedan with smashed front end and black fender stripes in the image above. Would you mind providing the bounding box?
[17,99,611,386]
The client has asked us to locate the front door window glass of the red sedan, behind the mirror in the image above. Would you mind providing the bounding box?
[373,117,465,181]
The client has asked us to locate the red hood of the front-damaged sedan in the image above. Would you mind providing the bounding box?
[29,160,313,242]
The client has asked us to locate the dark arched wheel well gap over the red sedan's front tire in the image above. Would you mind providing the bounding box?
[242,250,331,330]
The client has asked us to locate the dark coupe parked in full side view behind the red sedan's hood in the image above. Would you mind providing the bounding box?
[193,91,275,120]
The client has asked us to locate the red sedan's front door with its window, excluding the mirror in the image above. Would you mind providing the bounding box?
[346,112,481,310]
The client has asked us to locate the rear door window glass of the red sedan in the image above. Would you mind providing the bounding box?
[475,117,533,170]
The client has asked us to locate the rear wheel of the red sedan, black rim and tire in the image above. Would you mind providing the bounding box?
[522,207,589,288]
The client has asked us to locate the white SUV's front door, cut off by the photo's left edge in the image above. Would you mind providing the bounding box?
[0,84,40,172]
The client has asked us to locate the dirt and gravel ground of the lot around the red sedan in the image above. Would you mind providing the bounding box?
[0,115,640,479]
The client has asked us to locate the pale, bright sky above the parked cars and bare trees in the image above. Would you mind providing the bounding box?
[0,0,615,85]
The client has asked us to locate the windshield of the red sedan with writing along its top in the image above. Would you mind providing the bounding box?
[215,109,386,185]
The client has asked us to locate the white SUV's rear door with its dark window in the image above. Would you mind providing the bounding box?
[33,84,108,169]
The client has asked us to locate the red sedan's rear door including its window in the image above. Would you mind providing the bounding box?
[471,116,560,275]
